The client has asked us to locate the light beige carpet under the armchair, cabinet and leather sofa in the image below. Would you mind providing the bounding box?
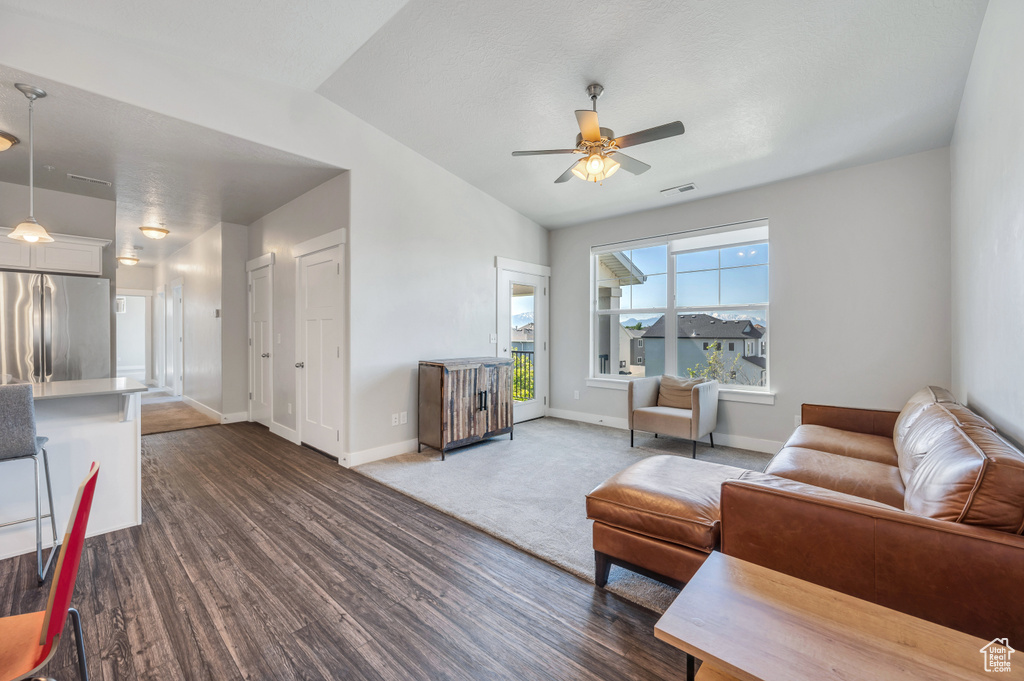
[355,418,770,612]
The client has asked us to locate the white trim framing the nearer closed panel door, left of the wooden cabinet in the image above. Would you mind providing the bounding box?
[292,241,349,458]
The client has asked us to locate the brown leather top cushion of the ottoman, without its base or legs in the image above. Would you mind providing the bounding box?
[587,455,743,553]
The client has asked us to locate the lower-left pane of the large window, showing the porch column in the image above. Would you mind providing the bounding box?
[594,314,665,378]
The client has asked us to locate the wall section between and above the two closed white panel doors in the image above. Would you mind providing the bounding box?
[249,173,349,429]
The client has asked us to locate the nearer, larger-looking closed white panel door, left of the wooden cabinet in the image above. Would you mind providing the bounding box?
[296,246,343,458]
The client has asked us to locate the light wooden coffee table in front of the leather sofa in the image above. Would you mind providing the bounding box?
[654,551,1003,681]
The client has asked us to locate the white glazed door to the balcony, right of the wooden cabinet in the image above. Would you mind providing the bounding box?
[498,269,548,423]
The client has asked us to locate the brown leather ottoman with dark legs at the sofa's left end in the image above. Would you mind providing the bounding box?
[587,455,751,587]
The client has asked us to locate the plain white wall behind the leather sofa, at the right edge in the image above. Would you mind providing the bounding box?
[951,0,1024,443]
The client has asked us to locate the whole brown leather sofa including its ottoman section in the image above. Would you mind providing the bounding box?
[587,388,1024,640]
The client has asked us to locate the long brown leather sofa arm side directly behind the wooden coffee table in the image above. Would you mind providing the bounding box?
[721,472,1024,640]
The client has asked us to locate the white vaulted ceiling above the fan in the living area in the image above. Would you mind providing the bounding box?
[318,0,986,227]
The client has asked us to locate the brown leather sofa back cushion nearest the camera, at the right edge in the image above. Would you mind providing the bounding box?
[904,425,1024,535]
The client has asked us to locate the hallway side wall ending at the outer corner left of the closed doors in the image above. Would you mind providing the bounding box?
[156,224,223,413]
